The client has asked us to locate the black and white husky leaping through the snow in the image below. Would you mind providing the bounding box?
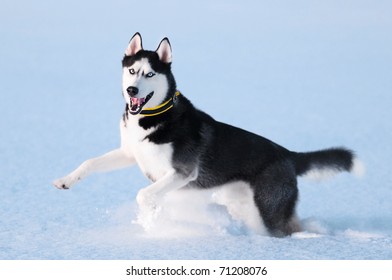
[53,33,361,236]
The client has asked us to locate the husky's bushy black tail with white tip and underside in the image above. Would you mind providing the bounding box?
[292,148,365,180]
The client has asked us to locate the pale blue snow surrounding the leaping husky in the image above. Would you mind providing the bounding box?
[0,0,392,260]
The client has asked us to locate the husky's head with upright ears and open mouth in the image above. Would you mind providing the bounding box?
[122,33,176,115]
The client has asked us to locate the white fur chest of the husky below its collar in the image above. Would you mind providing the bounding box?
[121,120,173,181]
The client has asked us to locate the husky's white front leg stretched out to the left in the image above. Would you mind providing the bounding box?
[53,149,135,189]
